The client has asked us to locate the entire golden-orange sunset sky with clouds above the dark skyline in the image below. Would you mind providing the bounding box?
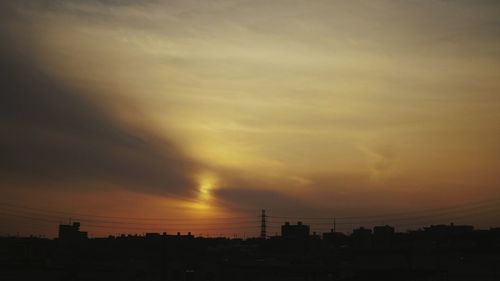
[0,0,500,237]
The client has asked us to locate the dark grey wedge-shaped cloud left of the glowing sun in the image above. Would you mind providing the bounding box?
[0,8,198,196]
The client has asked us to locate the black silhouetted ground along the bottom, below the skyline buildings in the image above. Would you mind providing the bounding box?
[0,225,500,281]
